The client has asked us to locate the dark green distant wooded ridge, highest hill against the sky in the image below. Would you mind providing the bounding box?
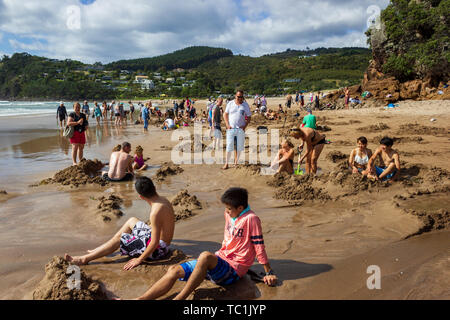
[106,46,233,72]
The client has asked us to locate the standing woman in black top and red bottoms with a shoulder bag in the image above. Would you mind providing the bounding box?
[67,102,89,165]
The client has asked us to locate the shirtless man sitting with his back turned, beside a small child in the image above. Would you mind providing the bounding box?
[102,142,134,182]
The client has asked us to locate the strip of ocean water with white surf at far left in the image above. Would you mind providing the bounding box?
[0,101,65,117]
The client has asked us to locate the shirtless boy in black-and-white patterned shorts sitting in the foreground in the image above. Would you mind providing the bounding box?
[64,177,175,270]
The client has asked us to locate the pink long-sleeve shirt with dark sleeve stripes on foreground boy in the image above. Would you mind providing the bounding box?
[216,210,269,277]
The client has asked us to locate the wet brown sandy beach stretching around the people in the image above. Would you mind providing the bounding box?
[0,98,450,299]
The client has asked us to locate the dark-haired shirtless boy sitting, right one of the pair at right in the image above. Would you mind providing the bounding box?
[363,137,400,181]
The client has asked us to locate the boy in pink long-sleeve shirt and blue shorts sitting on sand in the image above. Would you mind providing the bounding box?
[128,188,277,300]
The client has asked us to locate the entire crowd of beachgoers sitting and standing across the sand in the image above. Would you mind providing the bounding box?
[57,90,401,299]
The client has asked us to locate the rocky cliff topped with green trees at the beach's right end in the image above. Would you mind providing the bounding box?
[361,0,450,102]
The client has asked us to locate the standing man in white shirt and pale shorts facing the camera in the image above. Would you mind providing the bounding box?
[222,90,252,170]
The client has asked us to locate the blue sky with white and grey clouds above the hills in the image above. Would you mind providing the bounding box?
[0,0,389,63]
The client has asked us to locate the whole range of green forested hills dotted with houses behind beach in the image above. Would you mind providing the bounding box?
[0,47,371,100]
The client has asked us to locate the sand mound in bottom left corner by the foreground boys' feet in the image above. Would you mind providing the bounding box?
[33,257,107,300]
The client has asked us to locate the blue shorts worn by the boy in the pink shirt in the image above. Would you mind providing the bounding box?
[180,256,240,285]
